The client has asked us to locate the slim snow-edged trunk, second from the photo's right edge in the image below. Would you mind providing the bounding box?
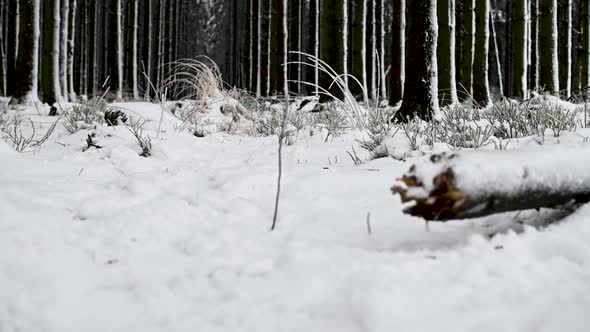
[558,0,572,98]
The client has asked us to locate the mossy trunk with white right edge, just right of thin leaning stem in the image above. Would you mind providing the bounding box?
[512,0,528,99]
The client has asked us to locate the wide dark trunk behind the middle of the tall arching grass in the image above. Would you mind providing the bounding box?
[320,0,346,101]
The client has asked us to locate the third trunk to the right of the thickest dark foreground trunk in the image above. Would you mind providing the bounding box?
[473,0,491,107]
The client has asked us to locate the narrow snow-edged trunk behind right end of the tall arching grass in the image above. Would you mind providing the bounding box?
[348,0,366,100]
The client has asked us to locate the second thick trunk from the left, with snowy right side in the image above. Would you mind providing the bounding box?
[41,0,61,105]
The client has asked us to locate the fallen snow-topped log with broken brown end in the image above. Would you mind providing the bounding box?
[391,146,590,221]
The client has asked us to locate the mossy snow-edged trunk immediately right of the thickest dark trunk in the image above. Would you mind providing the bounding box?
[437,0,457,106]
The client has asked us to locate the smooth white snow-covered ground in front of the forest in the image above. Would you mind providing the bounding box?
[0,103,590,332]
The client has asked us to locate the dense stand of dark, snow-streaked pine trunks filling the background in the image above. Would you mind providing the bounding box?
[0,0,590,117]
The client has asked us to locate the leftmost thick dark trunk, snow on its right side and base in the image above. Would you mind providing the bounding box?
[11,0,40,104]
